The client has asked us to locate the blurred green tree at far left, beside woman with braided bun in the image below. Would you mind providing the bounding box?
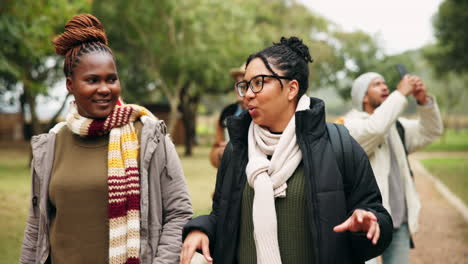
[0,0,87,135]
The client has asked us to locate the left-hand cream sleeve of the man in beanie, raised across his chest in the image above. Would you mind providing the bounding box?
[344,91,407,156]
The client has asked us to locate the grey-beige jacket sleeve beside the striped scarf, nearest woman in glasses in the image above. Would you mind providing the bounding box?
[153,135,193,263]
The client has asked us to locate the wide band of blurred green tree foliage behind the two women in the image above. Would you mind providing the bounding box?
[0,0,382,136]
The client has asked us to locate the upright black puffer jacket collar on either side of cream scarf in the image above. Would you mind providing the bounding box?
[227,97,326,144]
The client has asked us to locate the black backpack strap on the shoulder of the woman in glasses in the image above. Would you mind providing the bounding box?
[327,122,354,177]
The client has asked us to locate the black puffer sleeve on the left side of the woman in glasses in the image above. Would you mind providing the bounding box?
[182,143,232,254]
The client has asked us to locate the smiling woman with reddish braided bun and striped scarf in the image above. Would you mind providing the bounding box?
[20,14,192,264]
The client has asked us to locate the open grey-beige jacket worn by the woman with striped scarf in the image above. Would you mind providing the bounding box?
[20,117,193,264]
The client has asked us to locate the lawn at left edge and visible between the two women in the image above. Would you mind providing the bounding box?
[0,144,216,264]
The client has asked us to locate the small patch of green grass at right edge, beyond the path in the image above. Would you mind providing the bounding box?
[423,129,468,151]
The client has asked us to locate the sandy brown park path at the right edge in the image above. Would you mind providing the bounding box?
[192,152,468,264]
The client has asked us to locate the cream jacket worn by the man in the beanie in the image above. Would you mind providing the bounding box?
[344,91,443,233]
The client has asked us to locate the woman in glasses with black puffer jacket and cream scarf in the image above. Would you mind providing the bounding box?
[181,37,392,264]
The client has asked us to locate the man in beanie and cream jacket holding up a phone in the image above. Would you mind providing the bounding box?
[343,72,443,264]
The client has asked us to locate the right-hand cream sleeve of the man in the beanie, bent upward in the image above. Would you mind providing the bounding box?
[400,96,444,153]
